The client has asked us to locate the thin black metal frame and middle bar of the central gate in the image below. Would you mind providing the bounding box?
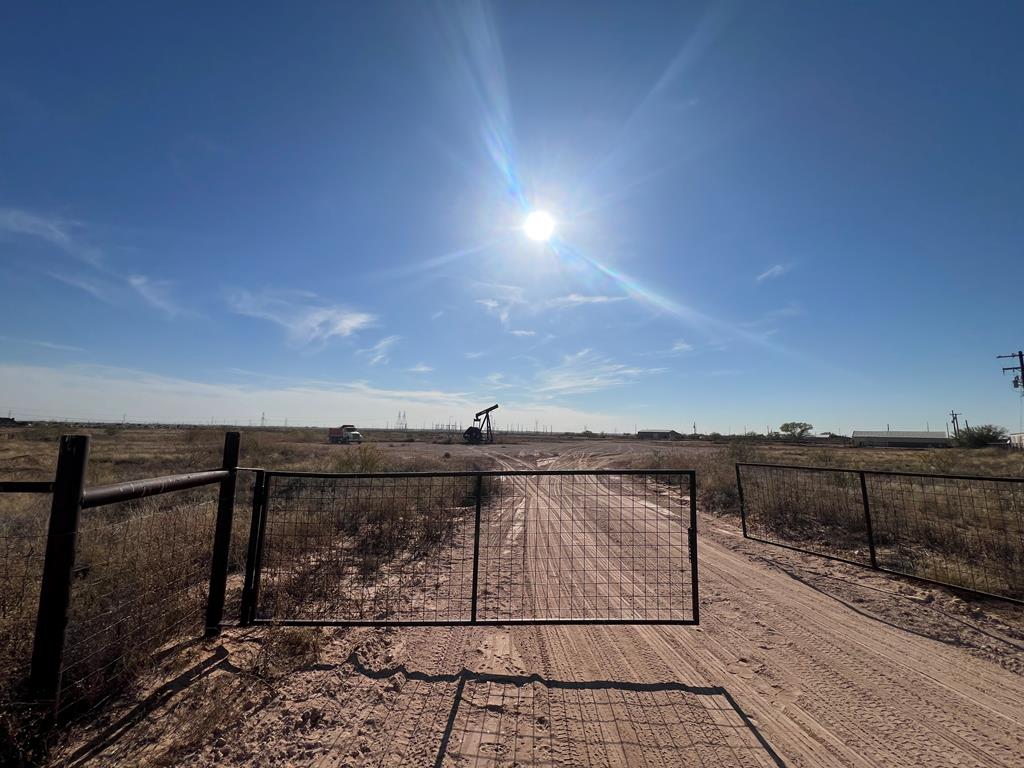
[240,469,700,627]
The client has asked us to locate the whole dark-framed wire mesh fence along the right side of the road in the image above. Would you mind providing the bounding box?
[736,464,1024,602]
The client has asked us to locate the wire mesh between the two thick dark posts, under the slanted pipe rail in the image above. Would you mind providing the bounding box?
[60,490,216,711]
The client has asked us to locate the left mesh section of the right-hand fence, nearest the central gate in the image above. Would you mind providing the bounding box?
[737,464,871,565]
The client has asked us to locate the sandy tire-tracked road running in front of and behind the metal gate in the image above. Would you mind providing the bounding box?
[68,451,1024,768]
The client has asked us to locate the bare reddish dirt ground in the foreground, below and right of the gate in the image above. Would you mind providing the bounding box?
[59,443,1024,767]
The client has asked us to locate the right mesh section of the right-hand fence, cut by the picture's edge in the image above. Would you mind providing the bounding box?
[865,473,1024,600]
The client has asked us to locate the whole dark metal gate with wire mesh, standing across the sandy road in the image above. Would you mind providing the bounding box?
[242,470,699,626]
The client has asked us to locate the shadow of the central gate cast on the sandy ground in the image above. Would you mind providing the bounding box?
[346,653,785,768]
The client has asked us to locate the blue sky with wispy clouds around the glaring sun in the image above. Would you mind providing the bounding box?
[0,2,1024,431]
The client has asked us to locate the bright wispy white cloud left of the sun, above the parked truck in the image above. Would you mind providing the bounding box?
[227,291,377,346]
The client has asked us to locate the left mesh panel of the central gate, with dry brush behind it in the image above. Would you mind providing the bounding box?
[256,476,475,622]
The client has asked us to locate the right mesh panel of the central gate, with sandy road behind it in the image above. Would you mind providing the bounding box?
[477,472,694,623]
